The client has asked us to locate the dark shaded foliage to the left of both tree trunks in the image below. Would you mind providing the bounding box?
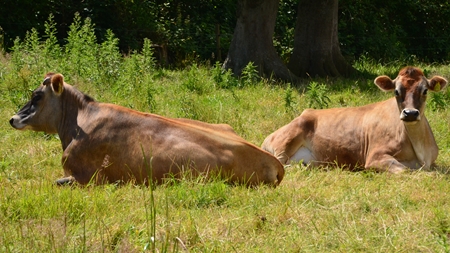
[0,0,236,65]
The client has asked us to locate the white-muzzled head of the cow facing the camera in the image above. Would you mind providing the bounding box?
[375,67,447,123]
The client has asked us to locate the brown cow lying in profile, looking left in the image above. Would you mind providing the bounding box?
[10,73,284,186]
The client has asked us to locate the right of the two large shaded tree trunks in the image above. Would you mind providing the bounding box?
[288,0,354,77]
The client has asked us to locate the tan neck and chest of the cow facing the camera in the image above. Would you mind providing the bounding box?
[404,115,435,167]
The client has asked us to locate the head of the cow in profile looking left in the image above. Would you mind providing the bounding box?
[9,73,64,133]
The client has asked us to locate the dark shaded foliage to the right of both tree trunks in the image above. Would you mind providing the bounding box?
[339,0,450,62]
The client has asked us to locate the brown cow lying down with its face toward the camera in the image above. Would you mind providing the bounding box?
[262,67,447,173]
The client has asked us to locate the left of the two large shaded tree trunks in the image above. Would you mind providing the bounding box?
[223,0,296,81]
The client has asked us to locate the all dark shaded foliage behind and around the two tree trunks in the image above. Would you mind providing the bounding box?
[0,0,450,75]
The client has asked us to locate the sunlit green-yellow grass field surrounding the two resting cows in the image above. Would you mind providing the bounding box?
[0,22,450,252]
